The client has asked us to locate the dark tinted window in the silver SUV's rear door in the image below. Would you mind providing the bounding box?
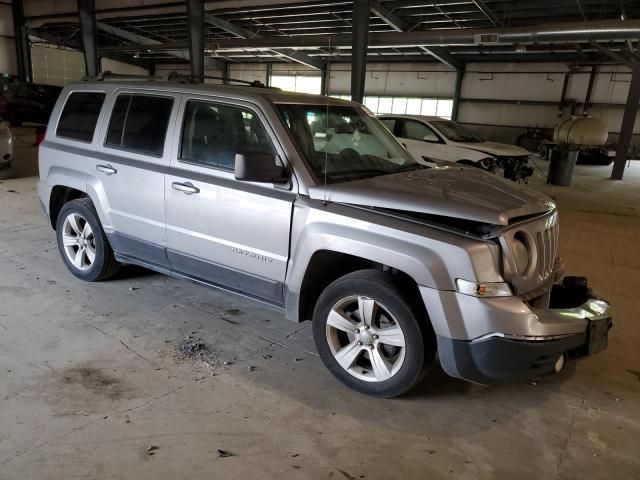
[105,95,173,157]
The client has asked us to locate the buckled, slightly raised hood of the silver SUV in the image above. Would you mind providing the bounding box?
[309,167,555,225]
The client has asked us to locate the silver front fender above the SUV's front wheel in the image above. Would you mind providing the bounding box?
[286,198,502,293]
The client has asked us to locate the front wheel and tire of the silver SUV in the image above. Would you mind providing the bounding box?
[313,270,435,398]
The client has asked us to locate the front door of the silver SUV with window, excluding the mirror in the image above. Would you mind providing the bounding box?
[165,96,296,304]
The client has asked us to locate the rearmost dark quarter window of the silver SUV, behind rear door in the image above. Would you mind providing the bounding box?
[56,92,105,143]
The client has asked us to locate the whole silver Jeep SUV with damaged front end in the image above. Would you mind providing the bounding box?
[38,80,612,397]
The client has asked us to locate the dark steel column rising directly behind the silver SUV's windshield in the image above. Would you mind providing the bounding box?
[351,0,370,103]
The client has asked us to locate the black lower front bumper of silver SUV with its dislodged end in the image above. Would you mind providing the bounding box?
[438,277,613,384]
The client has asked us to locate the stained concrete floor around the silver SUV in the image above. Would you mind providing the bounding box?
[0,129,640,480]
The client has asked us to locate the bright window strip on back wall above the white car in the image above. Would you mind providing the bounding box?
[334,95,453,120]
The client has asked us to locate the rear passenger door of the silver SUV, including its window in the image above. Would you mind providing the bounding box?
[87,89,180,267]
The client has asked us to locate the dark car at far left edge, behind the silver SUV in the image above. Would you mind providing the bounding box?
[0,82,62,127]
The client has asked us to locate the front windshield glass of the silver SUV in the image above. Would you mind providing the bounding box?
[277,104,424,183]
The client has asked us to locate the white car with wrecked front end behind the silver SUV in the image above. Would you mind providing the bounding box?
[379,114,533,182]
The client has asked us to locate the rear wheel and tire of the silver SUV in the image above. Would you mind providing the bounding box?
[56,198,120,282]
